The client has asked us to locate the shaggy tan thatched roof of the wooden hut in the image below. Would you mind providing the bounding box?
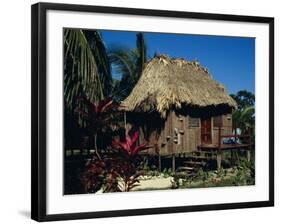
[121,55,236,117]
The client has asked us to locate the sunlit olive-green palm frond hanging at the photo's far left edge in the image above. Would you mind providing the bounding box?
[64,29,104,107]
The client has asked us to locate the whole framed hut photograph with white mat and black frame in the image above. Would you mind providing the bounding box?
[31,3,274,221]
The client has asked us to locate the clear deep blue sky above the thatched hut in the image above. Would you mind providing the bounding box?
[101,31,255,93]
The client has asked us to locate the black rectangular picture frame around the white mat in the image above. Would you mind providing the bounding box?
[31,3,274,221]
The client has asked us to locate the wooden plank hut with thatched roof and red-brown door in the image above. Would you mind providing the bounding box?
[122,55,236,168]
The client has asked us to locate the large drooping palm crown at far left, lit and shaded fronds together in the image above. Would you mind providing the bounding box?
[64,29,112,108]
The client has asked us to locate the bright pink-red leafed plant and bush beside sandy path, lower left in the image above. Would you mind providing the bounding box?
[82,131,149,193]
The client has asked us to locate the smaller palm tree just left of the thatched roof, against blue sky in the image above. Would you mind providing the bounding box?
[108,33,147,101]
